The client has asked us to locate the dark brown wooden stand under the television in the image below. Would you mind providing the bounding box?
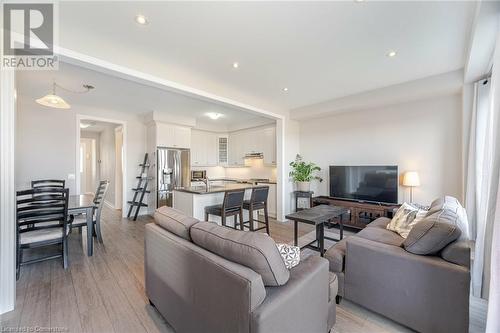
[312,196,399,229]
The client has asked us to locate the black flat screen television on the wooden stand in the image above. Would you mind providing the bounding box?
[330,165,398,204]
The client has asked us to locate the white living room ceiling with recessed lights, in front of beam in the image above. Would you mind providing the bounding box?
[60,0,476,109]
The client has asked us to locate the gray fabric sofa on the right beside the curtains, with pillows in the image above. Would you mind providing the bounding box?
[325,197,470,332]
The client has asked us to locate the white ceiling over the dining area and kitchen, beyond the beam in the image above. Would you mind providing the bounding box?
[18,62,273,131]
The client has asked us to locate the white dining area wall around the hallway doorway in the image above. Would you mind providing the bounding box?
[16,99,146,212]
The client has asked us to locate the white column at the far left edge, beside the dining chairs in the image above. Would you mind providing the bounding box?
[0,70,16,314]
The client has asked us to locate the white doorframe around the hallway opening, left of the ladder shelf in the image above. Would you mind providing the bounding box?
[75,114,128,217]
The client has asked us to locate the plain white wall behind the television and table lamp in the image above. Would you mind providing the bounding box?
[300,95,462,204]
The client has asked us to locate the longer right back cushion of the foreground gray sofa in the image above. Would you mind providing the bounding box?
[190,222,290,286]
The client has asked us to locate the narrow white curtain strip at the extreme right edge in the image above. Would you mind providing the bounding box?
[485,34,500,332]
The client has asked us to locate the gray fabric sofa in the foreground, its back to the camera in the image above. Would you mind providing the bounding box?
[145,208,337,333]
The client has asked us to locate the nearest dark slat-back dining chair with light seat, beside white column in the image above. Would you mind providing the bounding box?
[16,188,71,279]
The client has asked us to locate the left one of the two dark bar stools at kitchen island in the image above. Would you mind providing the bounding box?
[205,189,245,230]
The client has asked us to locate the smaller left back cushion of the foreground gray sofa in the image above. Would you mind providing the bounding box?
[154,206,200,241]
